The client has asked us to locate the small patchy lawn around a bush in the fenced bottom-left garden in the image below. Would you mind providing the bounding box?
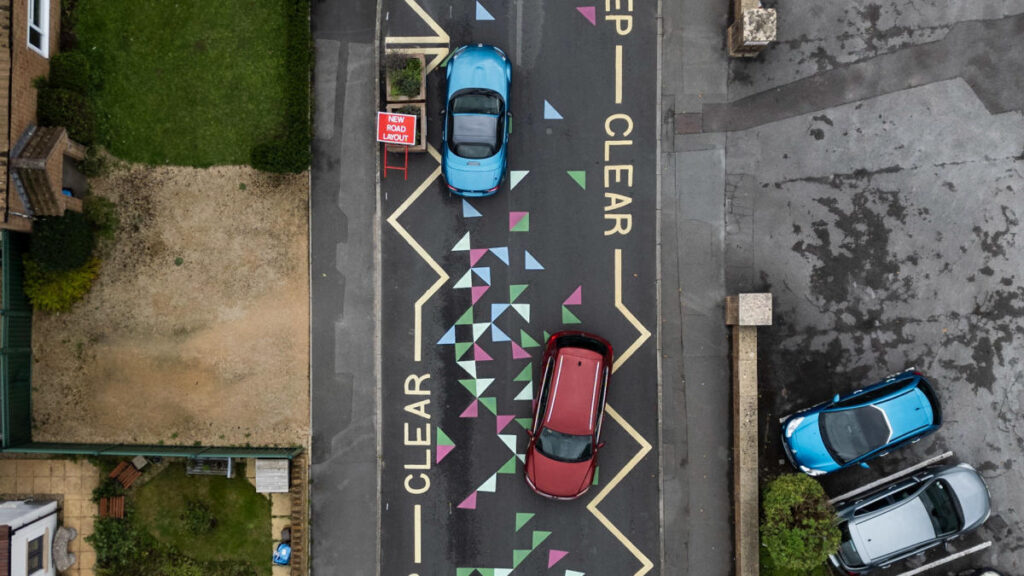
[135,464,273,575]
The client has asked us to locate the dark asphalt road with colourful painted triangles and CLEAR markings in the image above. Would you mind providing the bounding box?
[381,1,659,575]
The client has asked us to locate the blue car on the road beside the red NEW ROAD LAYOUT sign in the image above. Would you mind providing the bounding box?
[441,44,512,196]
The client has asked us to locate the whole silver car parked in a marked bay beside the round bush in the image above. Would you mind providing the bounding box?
[828,464,989,574]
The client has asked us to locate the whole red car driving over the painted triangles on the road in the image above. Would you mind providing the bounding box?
[526,331,611,500]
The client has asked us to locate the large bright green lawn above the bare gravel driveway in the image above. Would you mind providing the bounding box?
[74,0,299,166]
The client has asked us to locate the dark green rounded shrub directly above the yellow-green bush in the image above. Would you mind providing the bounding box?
[29,210,96,272]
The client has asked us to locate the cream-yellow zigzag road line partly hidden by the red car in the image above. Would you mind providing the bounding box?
[587,249,654,576]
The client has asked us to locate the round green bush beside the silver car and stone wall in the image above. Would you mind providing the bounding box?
[761,474,840,571]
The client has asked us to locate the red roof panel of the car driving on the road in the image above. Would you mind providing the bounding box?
[544,347,603,435]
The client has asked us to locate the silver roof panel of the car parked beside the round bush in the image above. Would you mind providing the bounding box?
[849,496,935,562]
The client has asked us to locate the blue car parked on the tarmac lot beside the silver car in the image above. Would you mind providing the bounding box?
[782,369,942,476]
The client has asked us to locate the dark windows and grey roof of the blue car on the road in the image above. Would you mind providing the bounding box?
[449,90,505,159]
